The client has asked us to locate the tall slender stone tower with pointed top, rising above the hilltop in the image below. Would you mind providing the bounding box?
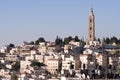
[88,8,95,42]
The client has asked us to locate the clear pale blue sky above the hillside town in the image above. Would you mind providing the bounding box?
[0,0,120,46]
